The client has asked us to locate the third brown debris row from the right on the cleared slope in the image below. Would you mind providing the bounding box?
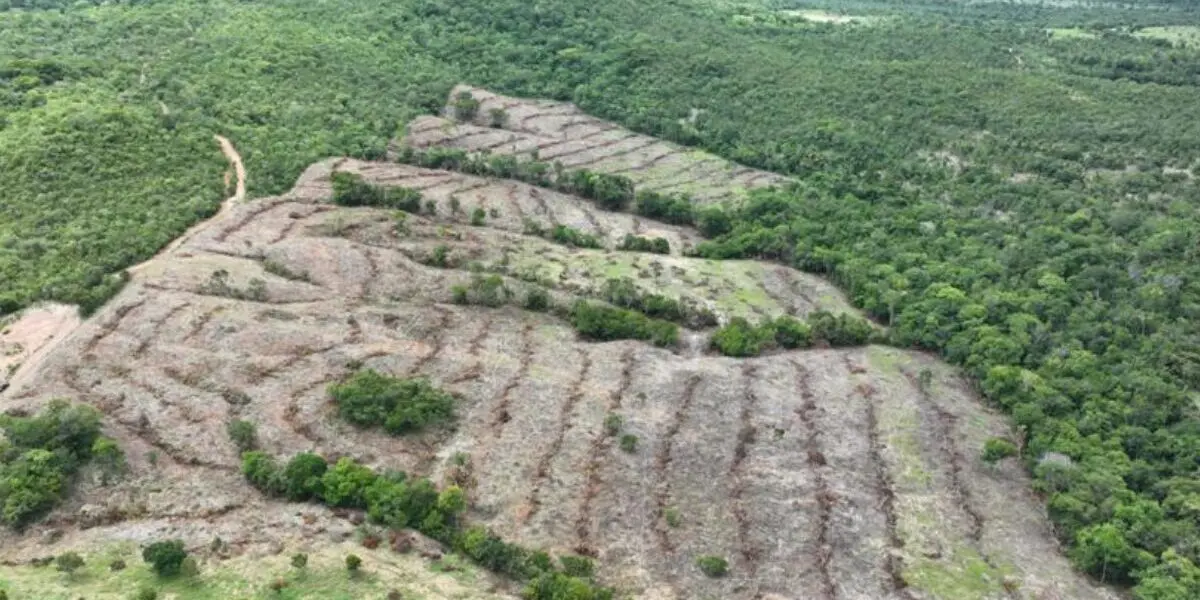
[791,360,838,600]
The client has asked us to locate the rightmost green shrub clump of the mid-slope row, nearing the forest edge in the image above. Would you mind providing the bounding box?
[712,311,880,358]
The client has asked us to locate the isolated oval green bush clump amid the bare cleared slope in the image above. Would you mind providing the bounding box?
[329,370,455,436]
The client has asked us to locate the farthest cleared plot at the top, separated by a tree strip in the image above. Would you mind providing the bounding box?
[394,85,790,204]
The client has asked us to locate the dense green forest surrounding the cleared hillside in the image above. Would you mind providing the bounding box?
[0,0,1200,600]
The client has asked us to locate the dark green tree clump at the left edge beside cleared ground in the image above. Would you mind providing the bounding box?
[0,400,125,528]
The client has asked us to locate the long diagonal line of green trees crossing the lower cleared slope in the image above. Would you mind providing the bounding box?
[241,451,613,600]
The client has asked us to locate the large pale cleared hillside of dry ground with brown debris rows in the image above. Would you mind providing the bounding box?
[0,90,1116,600]
